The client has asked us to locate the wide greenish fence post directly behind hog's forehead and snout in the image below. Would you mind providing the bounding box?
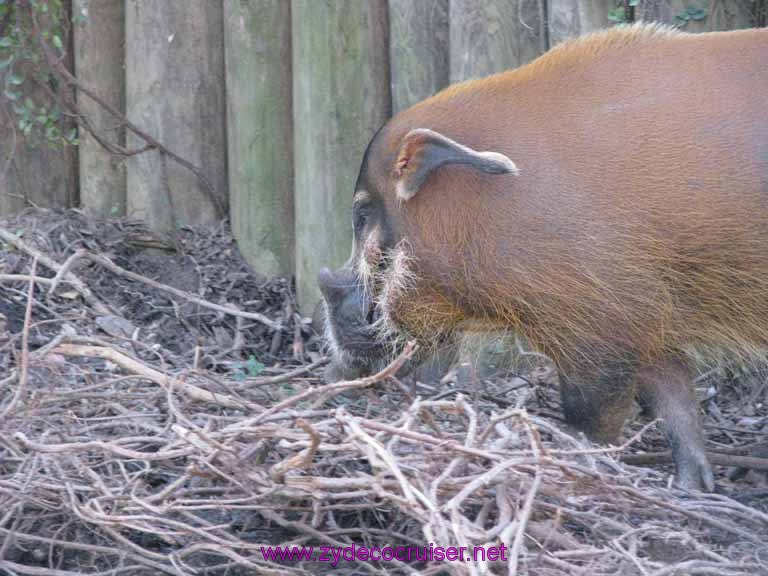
[291,0,391,314]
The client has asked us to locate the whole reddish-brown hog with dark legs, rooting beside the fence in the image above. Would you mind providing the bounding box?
[321,26,768,491]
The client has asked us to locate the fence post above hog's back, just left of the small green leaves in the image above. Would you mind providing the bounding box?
[547,0,616,47]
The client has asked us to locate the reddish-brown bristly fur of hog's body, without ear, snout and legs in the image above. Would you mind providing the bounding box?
[362,25,768,374]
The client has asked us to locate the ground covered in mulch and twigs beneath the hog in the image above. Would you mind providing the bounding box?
[0,210,768,576]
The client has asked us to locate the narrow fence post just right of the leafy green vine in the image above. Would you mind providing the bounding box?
[73,0,125,217]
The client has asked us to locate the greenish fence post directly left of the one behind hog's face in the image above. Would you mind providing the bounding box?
[224,0,294,276]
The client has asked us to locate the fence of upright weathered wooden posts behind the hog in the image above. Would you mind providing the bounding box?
[0,0,766,313]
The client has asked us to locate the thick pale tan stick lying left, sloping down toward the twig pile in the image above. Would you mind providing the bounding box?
[51,344,256,410]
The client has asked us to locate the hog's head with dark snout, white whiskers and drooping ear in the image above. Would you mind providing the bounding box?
[318,126,517,380]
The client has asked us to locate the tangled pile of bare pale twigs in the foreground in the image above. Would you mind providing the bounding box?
[0,209,768,576]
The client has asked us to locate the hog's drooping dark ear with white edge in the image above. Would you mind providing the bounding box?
[395,128,520,200]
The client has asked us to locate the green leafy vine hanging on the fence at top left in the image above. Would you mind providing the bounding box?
[0,0,78,147]
